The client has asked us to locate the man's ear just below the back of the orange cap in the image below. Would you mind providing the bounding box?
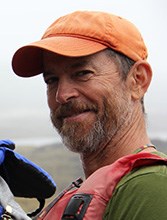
[128,60,152,100]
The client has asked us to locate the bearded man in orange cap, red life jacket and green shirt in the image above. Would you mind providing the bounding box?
[12,11,167,220]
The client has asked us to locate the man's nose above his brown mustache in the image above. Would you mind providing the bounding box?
[56,79,79,104]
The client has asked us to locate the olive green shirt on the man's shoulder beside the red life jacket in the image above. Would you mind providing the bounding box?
[103,152,167,220]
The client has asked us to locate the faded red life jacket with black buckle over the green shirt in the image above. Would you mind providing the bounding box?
[37,152,167,220]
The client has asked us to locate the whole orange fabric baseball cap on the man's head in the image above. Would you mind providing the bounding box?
[12,11,147,77]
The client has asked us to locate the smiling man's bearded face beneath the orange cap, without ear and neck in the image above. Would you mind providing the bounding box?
[43,51,132,153]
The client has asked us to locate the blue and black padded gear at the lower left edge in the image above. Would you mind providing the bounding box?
[0,140,56,199]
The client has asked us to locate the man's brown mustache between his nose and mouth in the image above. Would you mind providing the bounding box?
[54,100,98,119]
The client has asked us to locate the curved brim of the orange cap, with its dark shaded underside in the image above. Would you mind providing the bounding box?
[12,36,107,77]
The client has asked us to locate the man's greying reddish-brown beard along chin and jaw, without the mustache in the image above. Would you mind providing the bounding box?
[51,89,132,153]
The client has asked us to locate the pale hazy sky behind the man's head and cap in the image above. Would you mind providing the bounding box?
[0,0,167,141]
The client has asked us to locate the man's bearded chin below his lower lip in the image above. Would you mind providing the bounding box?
[51,117,105,153]
